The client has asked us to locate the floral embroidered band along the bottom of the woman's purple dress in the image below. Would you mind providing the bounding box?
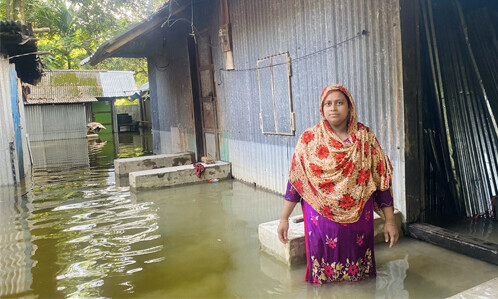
[311,248,375,284]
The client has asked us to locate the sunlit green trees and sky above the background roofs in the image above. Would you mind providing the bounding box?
[0,0,166,86]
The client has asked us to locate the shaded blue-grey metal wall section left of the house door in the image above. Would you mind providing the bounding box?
[147,22,196,153]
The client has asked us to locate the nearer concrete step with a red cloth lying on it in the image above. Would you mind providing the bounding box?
[130,161,232,191]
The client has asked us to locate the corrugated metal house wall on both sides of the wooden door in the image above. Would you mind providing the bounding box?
[148,0,405,216]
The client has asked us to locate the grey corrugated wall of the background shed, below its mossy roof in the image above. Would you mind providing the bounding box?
[24,104,86,141]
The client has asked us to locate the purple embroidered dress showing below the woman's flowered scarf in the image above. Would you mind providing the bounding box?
[285,182,393,284]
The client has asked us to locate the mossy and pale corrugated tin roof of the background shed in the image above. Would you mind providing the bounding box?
[24,70,137,105]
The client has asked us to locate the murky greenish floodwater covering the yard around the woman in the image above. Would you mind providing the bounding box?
[0,135,498,298]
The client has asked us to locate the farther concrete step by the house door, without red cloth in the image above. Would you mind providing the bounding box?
[114,152,195,177]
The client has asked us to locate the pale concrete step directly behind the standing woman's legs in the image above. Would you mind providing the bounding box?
[258,210,403,267]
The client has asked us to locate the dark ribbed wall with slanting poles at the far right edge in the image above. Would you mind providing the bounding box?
[420,0,498,223]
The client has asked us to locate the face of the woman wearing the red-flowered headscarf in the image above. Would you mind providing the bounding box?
[323,90,349,130]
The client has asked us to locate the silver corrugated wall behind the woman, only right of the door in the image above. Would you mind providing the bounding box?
[217,0,405,213]
